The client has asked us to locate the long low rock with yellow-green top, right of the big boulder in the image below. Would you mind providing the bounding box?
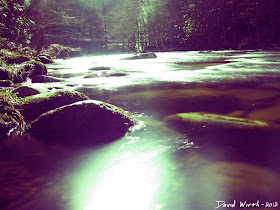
[165,112,279,145]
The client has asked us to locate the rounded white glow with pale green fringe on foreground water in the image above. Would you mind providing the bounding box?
[71,137,167,210]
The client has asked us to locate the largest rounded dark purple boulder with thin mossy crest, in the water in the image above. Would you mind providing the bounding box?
[29,100,136,145]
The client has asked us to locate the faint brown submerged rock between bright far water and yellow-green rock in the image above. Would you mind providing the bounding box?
[111,88,242,115]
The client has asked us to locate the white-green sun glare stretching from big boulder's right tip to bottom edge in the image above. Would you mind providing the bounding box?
[71,115,193,210]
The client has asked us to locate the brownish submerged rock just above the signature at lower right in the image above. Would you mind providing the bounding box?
[188,162,280,203]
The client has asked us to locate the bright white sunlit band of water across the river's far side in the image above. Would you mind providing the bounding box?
[46,51,280,90]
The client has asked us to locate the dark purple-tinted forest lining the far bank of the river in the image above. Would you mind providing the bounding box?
[0,0,280,52]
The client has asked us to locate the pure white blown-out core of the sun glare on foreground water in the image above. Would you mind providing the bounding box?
[83,152,159,210]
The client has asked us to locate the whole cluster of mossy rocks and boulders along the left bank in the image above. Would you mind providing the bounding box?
[0,44,137,145]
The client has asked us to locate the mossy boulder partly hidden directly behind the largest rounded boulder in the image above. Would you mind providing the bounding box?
[21,90,89,121]
